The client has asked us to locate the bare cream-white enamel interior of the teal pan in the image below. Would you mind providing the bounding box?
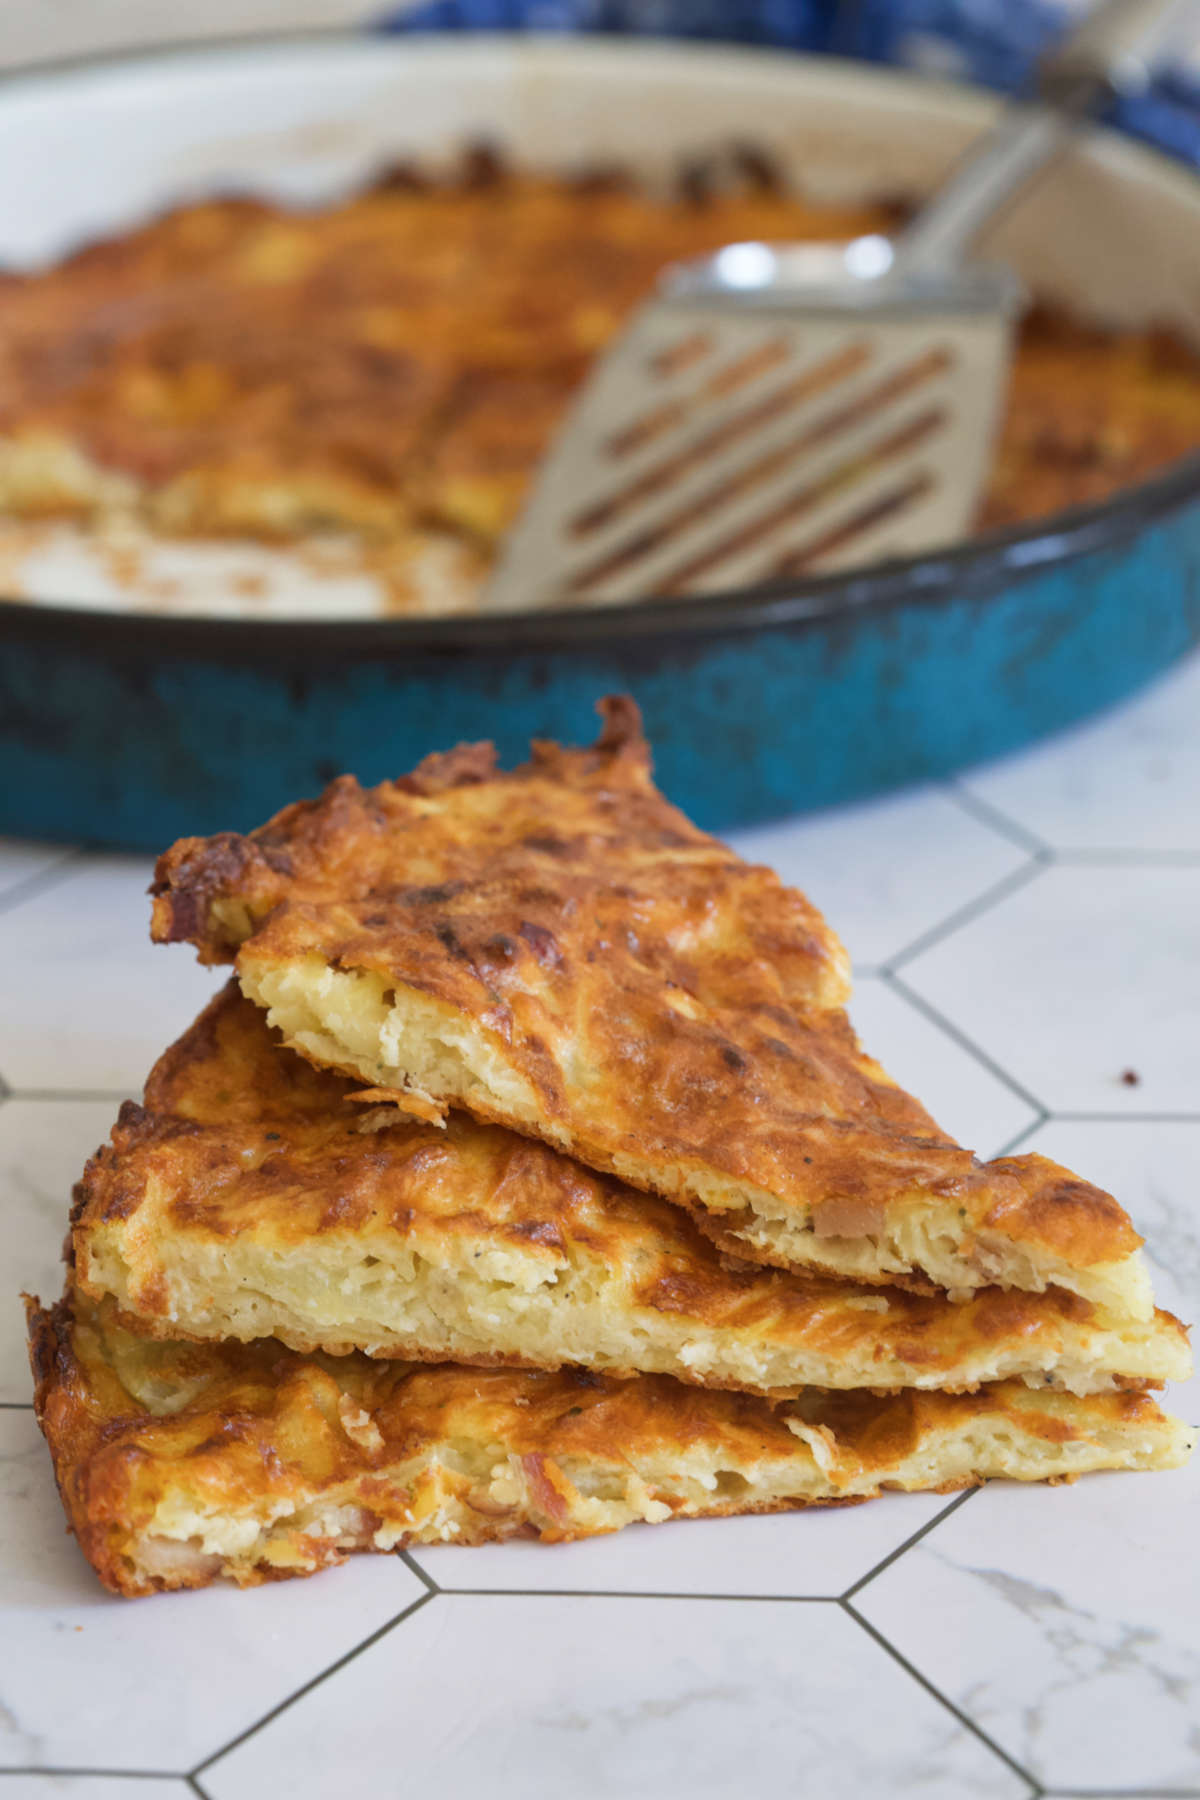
[0,36,1200,617]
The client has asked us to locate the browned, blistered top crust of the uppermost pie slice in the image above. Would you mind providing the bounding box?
[153,702,1141,1288]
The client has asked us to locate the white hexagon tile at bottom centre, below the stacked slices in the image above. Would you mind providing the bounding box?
[201,1598,1027,1800]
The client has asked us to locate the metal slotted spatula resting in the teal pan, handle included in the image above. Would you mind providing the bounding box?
[486,0,1198,612]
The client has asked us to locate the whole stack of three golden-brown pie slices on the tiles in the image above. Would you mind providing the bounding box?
[31,700,1191,1593]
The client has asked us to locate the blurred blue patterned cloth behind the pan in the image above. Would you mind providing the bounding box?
[378,0,1200,167]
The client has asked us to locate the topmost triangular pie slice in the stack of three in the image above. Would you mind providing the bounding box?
[153,700,1153,1319]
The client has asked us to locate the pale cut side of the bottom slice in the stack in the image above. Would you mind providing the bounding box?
[112,1415,1191,1589]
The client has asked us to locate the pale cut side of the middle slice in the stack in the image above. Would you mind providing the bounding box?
[79,1226,1191,1395]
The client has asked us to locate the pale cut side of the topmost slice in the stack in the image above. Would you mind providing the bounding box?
[237,943,1153,1324]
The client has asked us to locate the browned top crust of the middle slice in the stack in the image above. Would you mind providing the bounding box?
[74,983,1182,1391]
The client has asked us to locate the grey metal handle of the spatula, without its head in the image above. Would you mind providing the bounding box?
[894,0,1200,277]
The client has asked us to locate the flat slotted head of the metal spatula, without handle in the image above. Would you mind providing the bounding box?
[486,284,1011,612]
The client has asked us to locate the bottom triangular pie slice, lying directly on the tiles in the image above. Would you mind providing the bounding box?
[29,1291,1193,1595]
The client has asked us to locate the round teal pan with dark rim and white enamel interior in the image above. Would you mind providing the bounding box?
[0,36,1200,848]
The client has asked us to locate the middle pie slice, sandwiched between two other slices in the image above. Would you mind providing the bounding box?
[74,983,1191,1395]
